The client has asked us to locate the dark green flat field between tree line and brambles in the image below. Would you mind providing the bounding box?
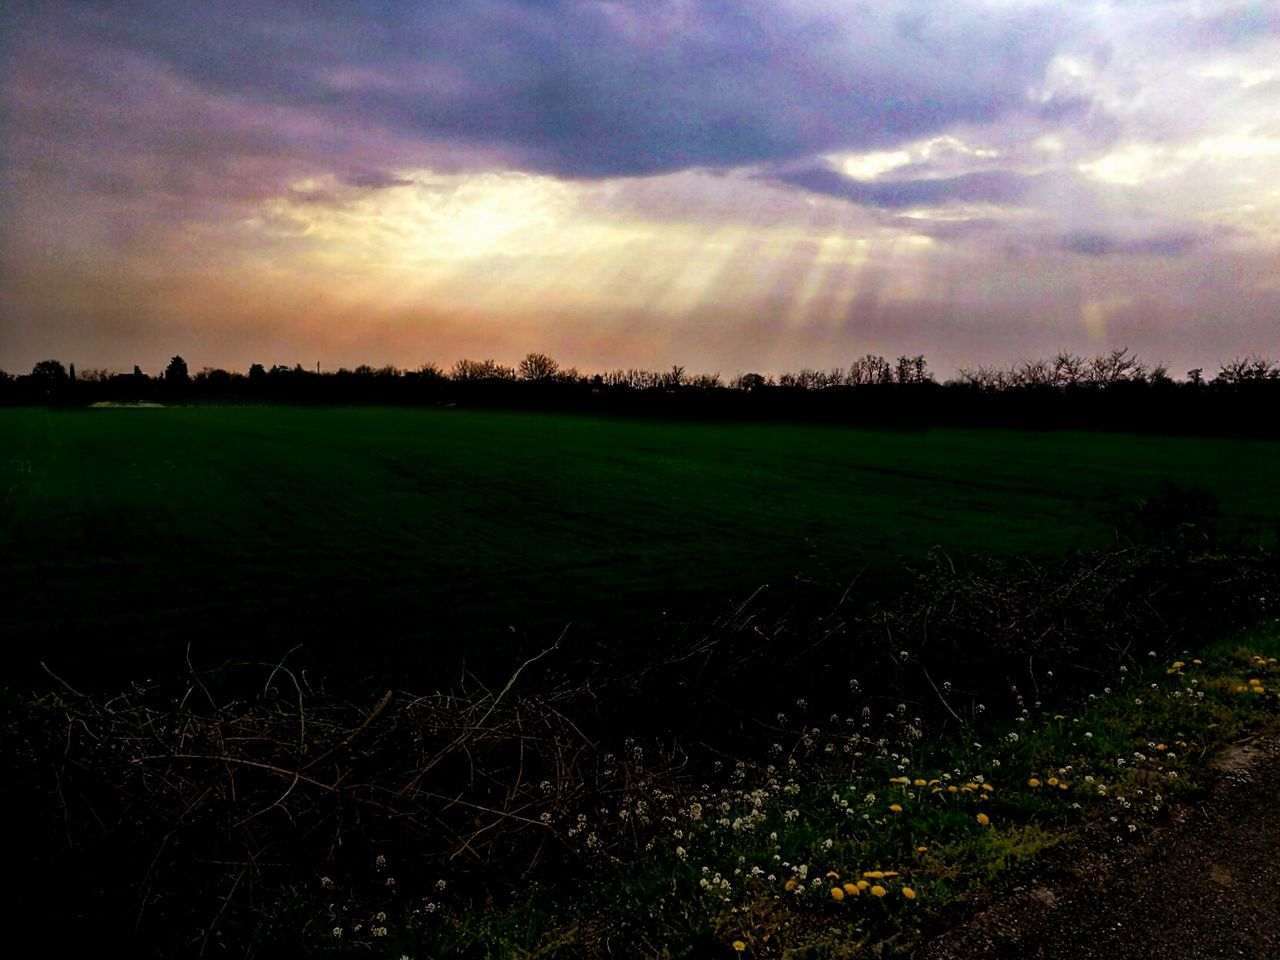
[0,407,1280,686]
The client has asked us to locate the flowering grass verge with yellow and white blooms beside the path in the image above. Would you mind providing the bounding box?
[389,623,1280,957]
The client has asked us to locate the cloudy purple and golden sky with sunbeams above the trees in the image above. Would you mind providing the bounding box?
[0,0,1280,376]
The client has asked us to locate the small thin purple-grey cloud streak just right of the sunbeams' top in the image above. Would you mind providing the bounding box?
[777,166,1039,210]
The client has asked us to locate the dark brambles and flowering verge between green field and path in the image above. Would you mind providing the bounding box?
[4,489,1280,957]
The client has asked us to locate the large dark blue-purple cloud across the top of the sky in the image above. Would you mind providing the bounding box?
[24,0,1069,177]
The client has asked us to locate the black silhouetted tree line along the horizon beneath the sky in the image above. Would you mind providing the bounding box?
[0,349,1280,435]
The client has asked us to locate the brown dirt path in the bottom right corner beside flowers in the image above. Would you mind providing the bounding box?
[914,732,1280,960]
